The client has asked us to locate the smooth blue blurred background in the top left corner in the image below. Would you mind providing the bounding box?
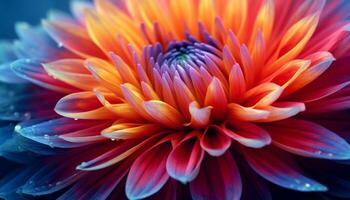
[0,0,70,40]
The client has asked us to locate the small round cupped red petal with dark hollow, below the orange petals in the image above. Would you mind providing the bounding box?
[200,125,231,156]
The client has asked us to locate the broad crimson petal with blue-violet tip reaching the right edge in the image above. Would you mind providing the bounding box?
[265,119,350,160]
